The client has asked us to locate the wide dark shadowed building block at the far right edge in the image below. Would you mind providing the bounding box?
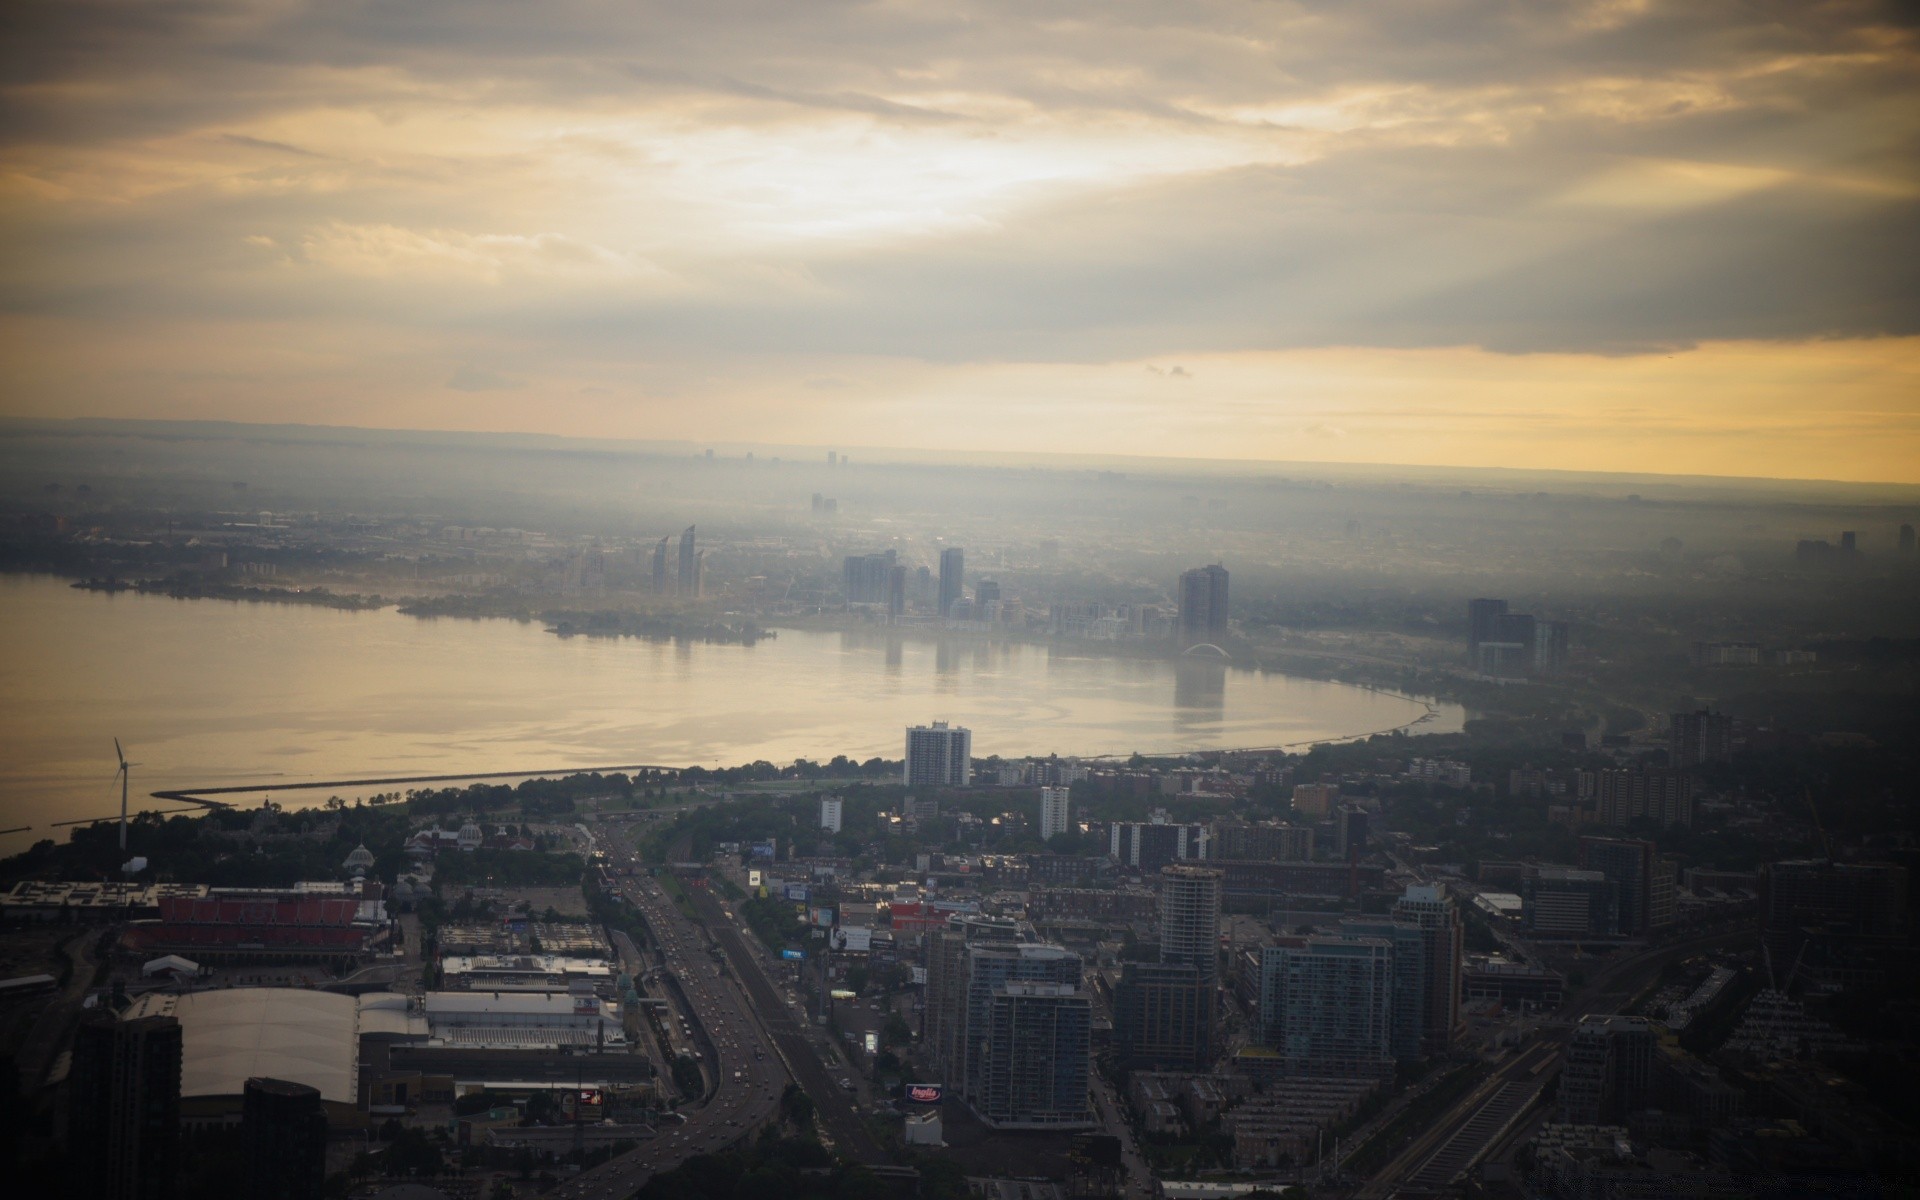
[1761,858,1907,963]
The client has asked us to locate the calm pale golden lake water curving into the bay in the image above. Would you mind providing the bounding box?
[0,576,1463,852]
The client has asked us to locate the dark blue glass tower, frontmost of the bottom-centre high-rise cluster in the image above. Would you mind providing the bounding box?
[970,983,1096,1129]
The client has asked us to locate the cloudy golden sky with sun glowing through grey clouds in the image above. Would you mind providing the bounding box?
[0,0,1920,482]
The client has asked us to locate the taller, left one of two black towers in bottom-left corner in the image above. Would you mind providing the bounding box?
[67,1014,180,1200]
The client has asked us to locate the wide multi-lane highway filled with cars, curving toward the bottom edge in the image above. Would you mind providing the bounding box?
[547,828,787,1200]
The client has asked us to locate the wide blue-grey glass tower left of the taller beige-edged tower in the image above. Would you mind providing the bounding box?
[1260,935,1394,1079]
